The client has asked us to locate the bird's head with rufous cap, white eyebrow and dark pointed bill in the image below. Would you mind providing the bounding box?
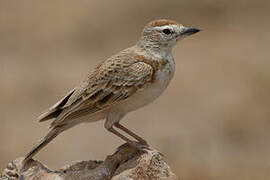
[140,19,200,50]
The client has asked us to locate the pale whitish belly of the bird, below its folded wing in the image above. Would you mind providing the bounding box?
[120,67,174,113]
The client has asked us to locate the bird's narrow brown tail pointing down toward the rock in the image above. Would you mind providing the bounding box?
[22,127,62,164]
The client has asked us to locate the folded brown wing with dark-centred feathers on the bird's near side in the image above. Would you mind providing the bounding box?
[48,57,154,127]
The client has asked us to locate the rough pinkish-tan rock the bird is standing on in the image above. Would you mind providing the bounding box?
[0,144,178,180]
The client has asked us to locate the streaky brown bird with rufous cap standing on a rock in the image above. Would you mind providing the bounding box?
[23,19,200,164]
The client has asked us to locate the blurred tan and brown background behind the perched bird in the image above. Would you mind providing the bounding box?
[0,0,270,180]
